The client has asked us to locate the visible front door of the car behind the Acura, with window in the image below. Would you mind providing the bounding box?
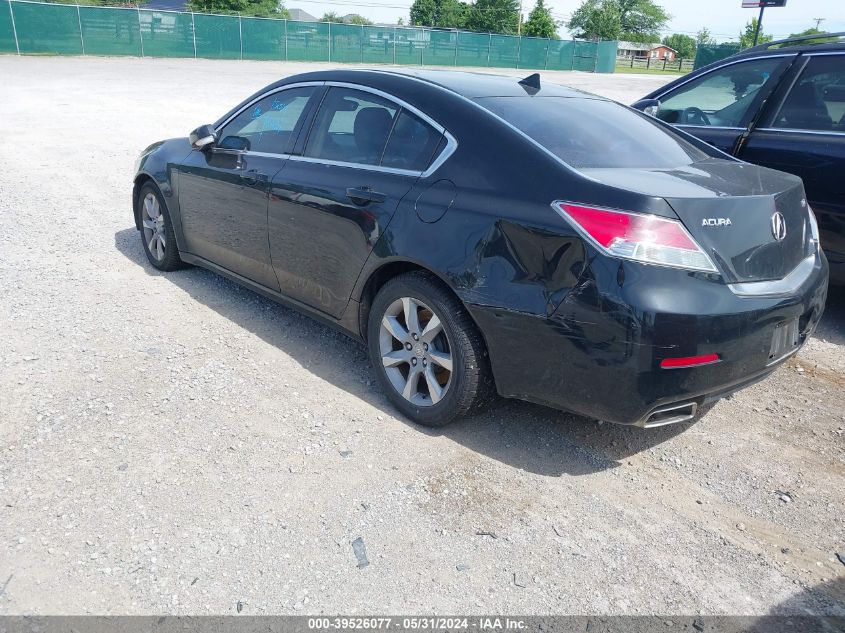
[656,55,794,154]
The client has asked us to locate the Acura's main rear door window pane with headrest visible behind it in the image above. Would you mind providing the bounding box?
[305,87,399,165]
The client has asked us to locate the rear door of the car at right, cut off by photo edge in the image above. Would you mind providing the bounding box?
[740,53,845,268]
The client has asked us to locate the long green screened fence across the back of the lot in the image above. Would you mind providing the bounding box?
[0,0,616,72]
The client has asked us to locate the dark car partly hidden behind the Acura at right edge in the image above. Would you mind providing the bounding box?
[634,33,845,284]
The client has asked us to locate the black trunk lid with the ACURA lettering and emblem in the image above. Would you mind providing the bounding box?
[582,159,809,283]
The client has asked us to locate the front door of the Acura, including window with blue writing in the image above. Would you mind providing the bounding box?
[178,86,317,290]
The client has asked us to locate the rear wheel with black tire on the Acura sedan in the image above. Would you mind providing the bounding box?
[367,272,494,427]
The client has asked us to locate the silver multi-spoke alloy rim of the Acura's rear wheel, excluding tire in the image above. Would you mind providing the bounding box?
[379,297,452,407]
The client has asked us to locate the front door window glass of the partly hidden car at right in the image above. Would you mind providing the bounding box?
[657,57,783,127]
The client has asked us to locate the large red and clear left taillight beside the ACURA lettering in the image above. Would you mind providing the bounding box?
[552,202,716,272]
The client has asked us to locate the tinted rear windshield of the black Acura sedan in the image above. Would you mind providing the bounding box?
[477,96,707,169]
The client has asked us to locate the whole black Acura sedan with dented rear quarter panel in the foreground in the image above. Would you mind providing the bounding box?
[133,70,828,427]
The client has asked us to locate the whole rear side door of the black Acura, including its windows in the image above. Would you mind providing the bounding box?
[268,85,444,318]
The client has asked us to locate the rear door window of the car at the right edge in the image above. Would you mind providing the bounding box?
[773,55,845,132]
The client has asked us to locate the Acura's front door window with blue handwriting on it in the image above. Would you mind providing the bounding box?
[217,87,314,154]
